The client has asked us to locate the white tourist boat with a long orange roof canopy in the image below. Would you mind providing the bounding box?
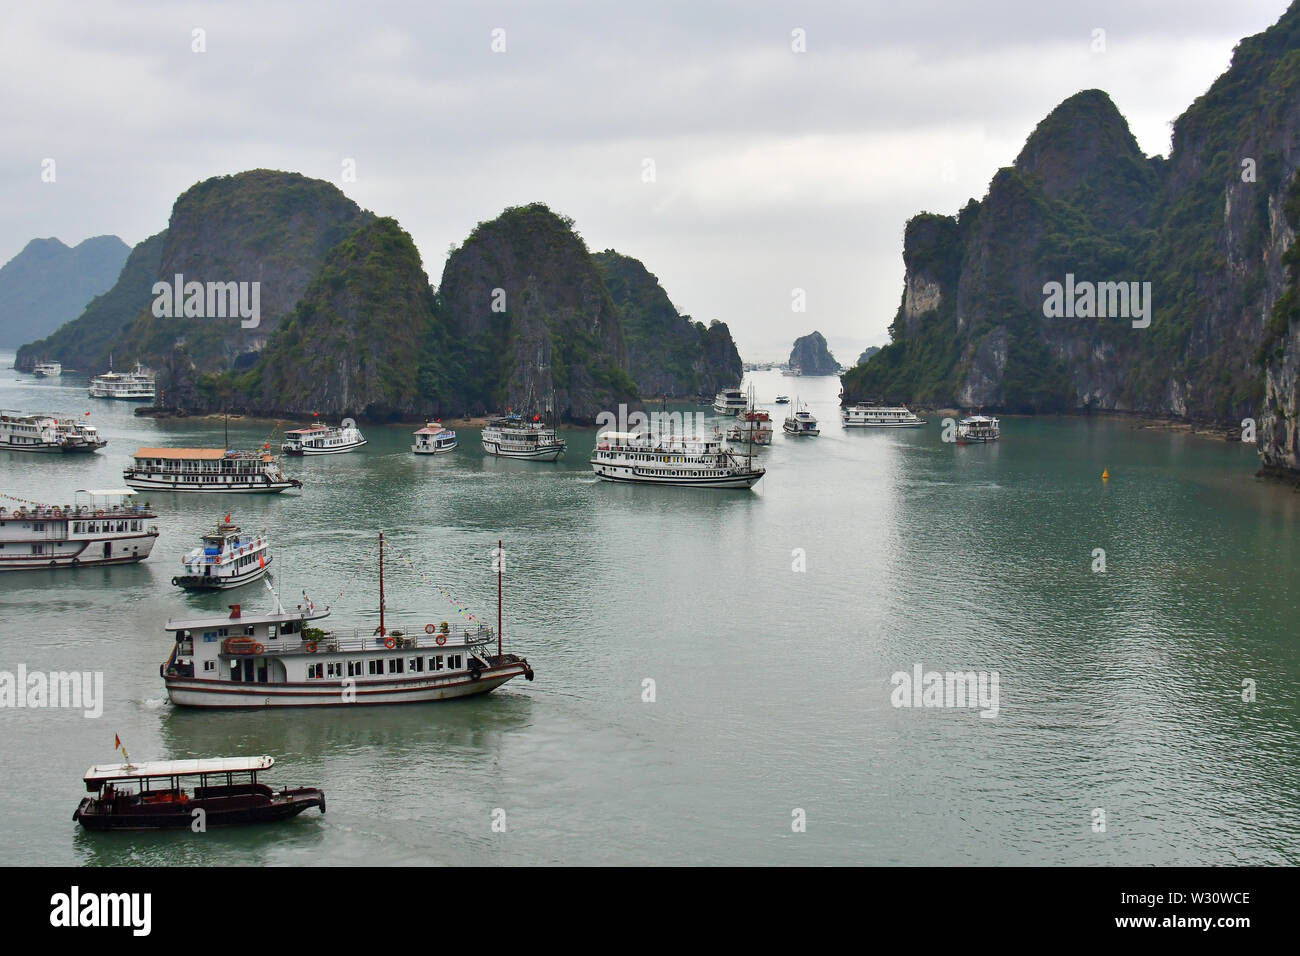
[122,446,303,494]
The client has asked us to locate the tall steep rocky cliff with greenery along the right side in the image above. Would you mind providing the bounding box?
[844,4,1300,458]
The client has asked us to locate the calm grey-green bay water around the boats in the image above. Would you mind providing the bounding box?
[0,355,1300,865]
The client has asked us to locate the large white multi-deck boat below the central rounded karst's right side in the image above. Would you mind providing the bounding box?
[592,432,767,488]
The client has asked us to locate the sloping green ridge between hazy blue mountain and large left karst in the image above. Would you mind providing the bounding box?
[14,232,166,375]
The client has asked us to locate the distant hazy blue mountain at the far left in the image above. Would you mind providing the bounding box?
[0,235,131,347]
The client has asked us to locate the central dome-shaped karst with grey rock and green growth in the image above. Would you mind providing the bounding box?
[438,203,637,423]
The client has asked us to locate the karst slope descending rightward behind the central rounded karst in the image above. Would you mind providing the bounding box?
[592,248,744,398]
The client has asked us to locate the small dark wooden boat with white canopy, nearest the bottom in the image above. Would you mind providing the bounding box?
[73,757,325,830]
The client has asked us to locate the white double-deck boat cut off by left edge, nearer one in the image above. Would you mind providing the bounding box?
[0,488,159,571]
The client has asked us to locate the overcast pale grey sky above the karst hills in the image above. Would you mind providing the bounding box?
[0,0,1287,364]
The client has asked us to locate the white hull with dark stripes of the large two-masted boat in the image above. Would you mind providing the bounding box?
[164,663,529,709]
